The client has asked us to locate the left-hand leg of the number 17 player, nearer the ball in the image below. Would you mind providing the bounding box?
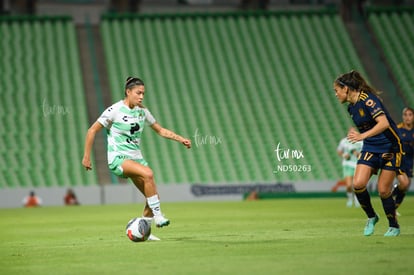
[353,164,379,236]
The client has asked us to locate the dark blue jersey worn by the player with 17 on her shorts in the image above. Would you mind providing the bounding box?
[348,92,403,153]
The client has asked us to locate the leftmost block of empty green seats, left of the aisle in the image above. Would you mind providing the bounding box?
[0,16,97,188]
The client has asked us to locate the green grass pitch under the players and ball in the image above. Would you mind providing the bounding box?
[0,197,414,275]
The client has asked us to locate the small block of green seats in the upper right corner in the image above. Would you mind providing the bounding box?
[368,7,414,106]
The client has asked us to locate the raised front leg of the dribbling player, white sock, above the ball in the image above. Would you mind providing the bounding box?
[122,159,170,227]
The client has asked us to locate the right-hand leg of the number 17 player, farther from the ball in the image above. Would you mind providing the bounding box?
[378,169,400,236]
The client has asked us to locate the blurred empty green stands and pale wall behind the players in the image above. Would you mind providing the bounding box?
[0,0,414,207]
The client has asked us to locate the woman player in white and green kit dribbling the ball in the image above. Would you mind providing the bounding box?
[82,77,191,239]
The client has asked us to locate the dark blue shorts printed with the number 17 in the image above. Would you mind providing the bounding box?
[357,151,402,173]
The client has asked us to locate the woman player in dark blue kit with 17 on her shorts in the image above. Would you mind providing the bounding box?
[333,71,403,237]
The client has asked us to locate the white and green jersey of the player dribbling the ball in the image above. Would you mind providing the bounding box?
[98,100,156,164]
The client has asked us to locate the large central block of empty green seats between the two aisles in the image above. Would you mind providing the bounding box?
[101,9,364,184]
